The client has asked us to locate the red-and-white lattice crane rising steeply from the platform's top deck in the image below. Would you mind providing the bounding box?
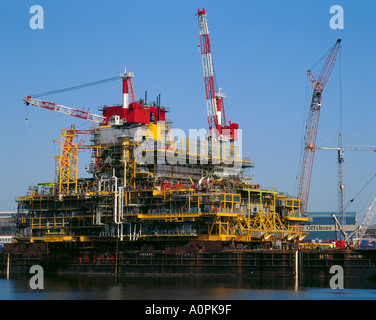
[196,9,239,140]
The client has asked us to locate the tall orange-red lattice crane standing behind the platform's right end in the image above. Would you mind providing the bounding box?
[298,39,341,212]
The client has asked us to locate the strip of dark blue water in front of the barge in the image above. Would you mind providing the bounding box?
[0,276,376,300]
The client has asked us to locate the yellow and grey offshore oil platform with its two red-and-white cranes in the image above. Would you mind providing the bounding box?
[17,9,308,247]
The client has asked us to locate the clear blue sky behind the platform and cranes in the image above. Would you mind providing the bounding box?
[0,0,376,221]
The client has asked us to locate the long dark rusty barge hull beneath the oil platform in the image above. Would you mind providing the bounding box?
[0,241,376,279]
